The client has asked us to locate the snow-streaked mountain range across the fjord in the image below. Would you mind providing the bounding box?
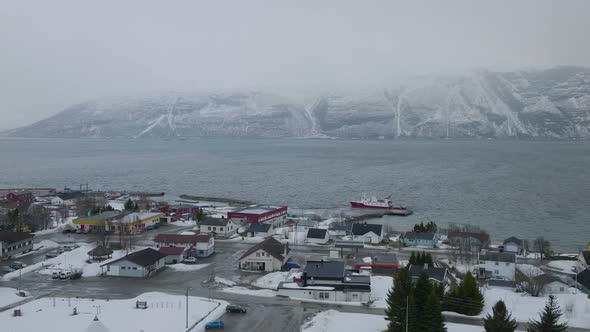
[7,67,590,139]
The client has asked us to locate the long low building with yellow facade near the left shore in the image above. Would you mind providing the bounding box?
[73,211,163,233]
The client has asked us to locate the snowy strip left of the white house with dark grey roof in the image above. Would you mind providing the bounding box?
[2,243,133,281]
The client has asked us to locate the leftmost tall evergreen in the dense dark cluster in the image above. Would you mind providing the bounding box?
[385,268,418,332]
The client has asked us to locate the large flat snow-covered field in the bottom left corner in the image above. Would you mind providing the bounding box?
[0,292,227,332]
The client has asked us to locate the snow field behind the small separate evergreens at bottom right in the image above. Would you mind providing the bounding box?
[481,288,590,328]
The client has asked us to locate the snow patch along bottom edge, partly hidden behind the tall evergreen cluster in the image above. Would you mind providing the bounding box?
[301,310,482,332]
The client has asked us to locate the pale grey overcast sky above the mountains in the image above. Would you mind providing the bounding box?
[0,0,590,129]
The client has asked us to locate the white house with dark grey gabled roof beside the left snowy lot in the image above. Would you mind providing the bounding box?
[101,248,166,278]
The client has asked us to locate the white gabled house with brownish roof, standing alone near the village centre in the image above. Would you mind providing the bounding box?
[238,237,290,272]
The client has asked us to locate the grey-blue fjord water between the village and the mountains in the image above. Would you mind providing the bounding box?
[0,138,590,251]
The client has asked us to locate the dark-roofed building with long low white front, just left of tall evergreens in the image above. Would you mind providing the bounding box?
[277,260,371,302]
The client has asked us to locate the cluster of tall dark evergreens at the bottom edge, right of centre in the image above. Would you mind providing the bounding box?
[385,268,447,332]
